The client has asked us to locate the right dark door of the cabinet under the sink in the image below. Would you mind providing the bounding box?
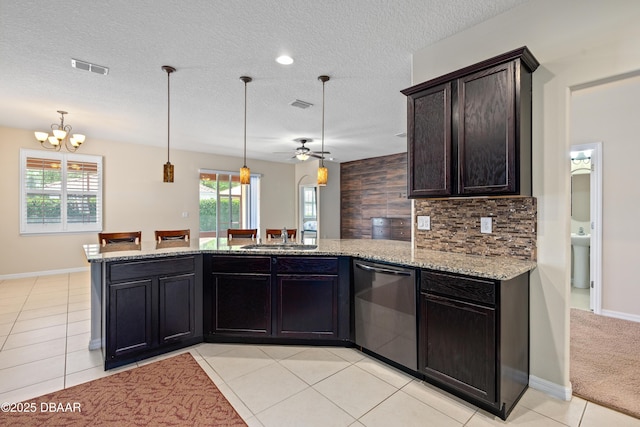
[277,274,338,338]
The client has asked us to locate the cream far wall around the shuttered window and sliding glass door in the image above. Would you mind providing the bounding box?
[0,127,297,277]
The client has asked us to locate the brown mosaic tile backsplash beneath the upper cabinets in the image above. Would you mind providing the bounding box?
[414,197,537,261]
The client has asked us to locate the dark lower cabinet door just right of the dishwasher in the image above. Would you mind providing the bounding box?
[419,293,497,403]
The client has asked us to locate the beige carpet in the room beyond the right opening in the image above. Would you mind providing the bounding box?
[570,308,640,418]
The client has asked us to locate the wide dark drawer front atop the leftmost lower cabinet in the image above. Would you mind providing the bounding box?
[108,256,196,282]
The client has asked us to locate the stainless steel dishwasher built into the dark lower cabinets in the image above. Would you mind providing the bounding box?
[353,259,418,370]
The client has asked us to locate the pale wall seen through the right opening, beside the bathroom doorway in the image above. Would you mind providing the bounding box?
[571,76,640,319]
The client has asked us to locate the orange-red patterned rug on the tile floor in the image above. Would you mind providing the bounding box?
[0,353,246,427]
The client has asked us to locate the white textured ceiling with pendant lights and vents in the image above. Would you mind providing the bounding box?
[0,0,525,162]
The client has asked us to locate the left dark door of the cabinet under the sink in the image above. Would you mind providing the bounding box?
[211,273,271,335]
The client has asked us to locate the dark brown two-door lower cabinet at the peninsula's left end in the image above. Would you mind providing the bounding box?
[103,255,202,369]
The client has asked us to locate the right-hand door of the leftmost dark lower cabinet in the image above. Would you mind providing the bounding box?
[158,274,196,344]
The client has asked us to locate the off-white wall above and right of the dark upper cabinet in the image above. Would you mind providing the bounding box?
[413,0,640,398]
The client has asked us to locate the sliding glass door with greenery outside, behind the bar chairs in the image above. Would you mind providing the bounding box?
[199,170,260,248]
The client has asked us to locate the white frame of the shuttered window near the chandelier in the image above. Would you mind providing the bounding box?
[20,148,104,235]
